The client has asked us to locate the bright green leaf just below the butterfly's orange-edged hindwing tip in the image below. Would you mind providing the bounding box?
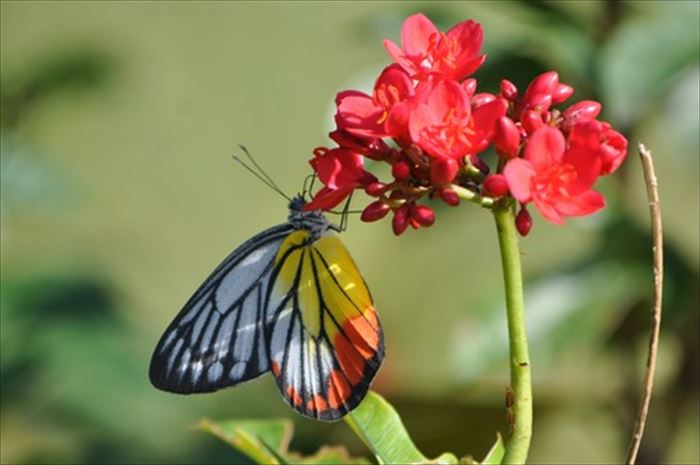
[345,391,429,463]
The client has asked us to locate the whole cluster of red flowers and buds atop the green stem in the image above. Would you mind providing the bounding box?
[305,14,627,235]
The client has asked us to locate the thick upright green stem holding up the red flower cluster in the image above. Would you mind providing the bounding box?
[493,204,532,463]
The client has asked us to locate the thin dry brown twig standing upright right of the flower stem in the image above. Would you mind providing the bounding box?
[625,144,664,465]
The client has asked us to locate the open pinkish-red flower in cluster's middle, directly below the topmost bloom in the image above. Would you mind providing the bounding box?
[409,81,506,159]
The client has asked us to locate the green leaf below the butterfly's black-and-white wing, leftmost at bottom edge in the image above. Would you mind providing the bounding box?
[197,419,292,464]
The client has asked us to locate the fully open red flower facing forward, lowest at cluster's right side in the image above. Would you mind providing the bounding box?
[503,127,605,224]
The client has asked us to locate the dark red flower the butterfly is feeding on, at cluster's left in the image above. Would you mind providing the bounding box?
[304,148,377,211]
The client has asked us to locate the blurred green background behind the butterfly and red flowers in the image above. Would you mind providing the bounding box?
[0,1,700,463]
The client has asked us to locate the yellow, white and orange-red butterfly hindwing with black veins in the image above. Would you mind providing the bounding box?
[268,230,384,421]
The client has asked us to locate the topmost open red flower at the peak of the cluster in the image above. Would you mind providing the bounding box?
[384,14,486,80]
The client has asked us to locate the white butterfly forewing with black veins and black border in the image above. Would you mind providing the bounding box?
[149,224,294,394]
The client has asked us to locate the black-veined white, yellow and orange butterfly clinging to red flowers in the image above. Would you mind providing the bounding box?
[149,196,384,421]
